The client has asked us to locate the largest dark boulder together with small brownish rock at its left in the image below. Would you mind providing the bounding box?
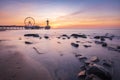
[78,64,112,80]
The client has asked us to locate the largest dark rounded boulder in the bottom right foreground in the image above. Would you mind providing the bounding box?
[86,64,112,80]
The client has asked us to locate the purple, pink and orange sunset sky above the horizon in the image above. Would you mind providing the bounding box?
[0,0,120,28]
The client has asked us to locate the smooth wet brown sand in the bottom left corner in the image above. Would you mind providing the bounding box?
[0,45,53,80]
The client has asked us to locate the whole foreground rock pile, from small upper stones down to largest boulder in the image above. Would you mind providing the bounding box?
[75,53,112,80]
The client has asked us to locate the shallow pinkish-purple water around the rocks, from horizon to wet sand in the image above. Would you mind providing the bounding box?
[0,29,120,80]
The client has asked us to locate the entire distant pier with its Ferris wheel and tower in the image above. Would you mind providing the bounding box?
[0,17,50,30]
